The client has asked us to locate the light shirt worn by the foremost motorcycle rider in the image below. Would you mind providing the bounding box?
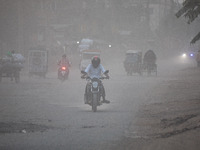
[85,64,105,79]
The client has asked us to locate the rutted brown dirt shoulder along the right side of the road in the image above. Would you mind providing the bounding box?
[116,60,200,150]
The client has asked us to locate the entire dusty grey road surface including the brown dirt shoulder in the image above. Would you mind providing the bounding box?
[0,55,200,150]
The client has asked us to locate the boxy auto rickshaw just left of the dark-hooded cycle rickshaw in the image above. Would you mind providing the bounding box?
[124,50,142,75]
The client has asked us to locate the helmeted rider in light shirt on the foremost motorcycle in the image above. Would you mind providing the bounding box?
[81,56,110,103]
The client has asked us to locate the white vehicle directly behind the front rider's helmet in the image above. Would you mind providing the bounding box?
[80,50,101,70]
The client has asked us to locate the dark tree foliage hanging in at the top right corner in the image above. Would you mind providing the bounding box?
[175,0,200,44]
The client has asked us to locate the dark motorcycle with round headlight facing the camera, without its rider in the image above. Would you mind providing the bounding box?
[81,70,109,112]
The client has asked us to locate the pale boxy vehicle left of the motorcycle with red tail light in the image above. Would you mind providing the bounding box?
[28,49,48,78]
